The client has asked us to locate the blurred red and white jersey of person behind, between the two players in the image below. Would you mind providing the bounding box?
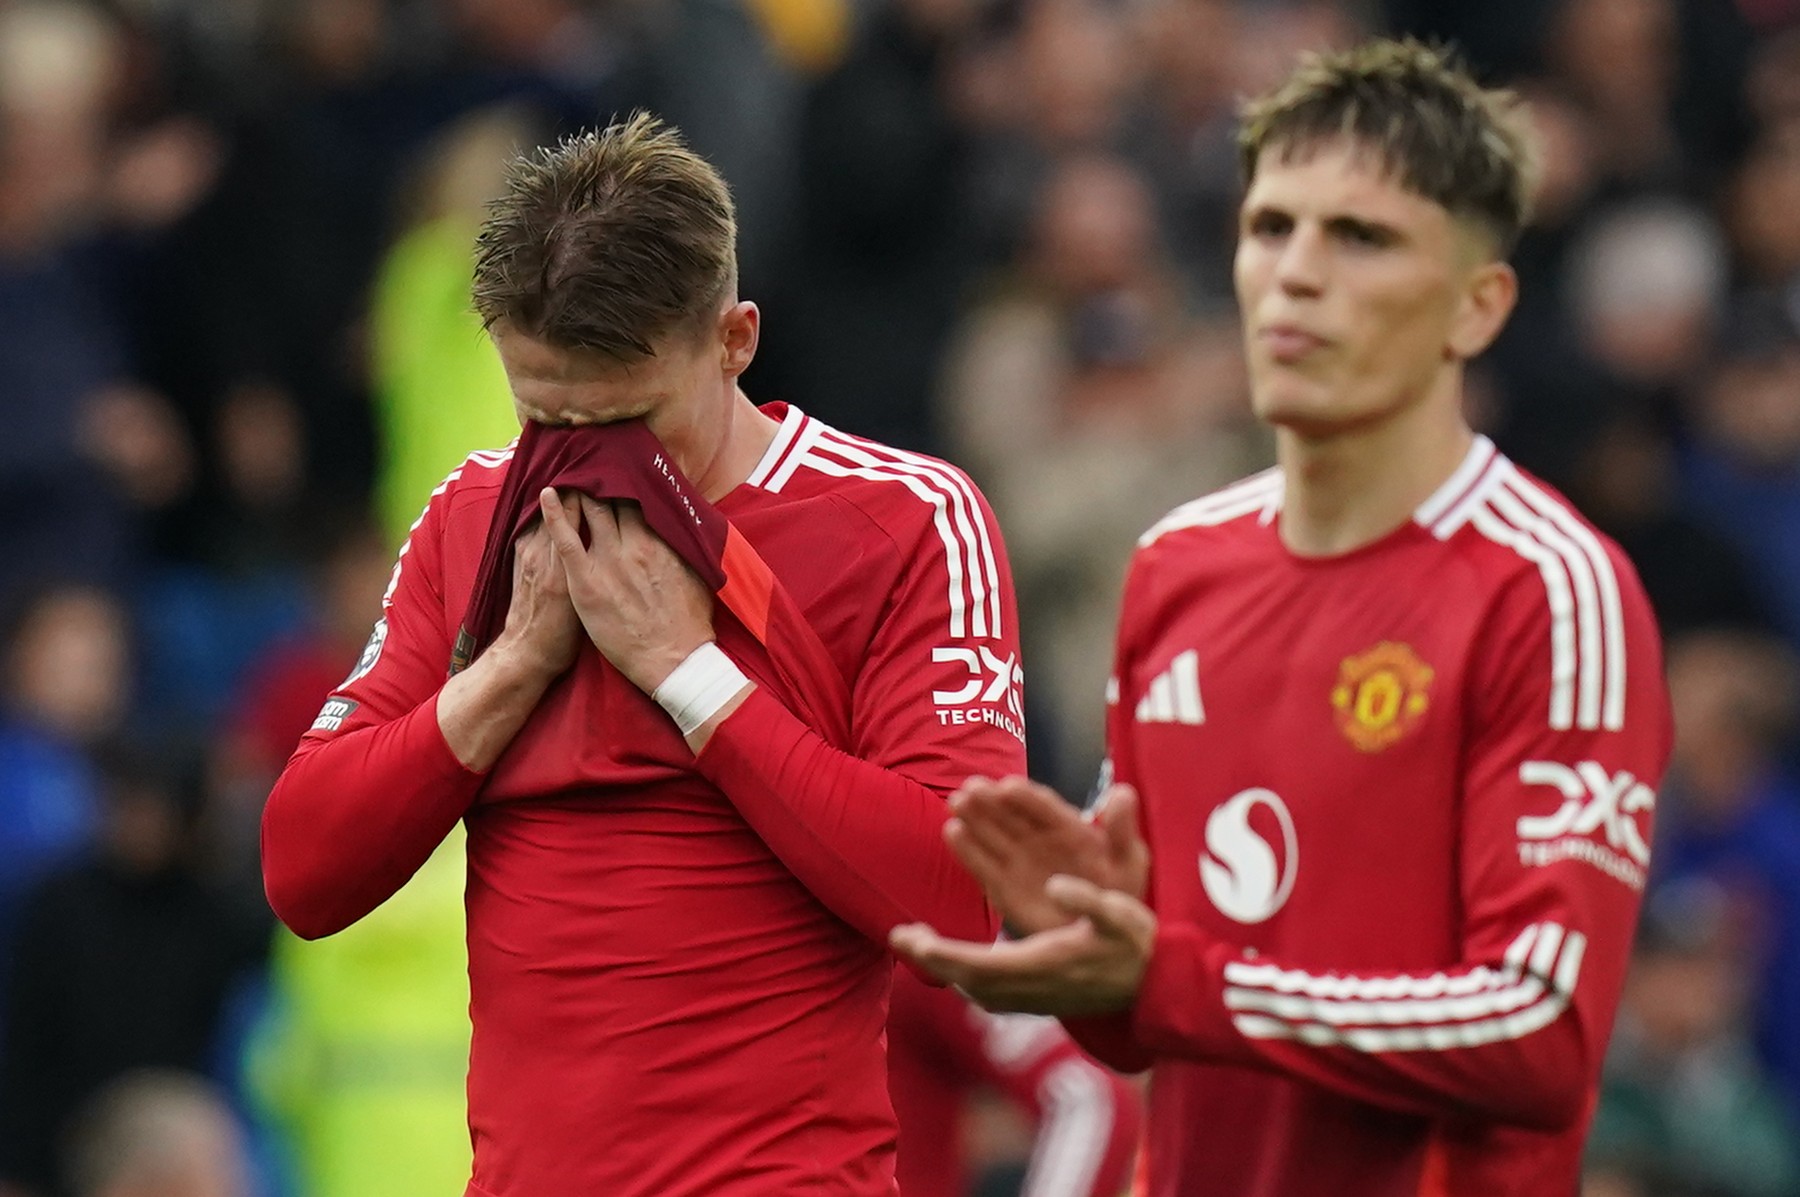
[887,968,1143,1197]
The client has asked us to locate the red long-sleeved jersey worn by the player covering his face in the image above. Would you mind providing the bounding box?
[265,405,1024,1197]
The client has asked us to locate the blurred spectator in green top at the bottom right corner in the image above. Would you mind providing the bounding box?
[1588,878,1800,1197]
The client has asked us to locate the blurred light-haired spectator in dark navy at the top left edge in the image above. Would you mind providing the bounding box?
[0,4,191,601]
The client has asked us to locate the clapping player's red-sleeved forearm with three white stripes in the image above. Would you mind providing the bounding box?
[1132,920,1622,1130]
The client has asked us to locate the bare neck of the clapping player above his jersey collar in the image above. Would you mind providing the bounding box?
[1276,371,1474,556]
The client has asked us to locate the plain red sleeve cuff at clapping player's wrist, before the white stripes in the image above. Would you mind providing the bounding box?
[1132,920,1244,1064]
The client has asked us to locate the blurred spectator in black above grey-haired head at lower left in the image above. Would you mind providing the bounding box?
[0,749,266,1193]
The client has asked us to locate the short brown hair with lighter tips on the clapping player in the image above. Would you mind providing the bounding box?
[1238,38,1535,254]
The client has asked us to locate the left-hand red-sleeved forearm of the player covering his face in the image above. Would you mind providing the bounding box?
[263,695,482,940]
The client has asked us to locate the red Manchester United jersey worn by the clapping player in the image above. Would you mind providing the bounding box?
[1076,437,1670,1197]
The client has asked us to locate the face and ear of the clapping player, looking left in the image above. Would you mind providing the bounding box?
[1233,144,1510,436]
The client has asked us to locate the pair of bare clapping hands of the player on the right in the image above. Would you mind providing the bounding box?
[889,778,1156,1017]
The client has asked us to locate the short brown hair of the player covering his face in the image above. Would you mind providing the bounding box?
[472,113,738,362]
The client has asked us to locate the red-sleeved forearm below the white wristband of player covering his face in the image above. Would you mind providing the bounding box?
[698,688,999,941]
